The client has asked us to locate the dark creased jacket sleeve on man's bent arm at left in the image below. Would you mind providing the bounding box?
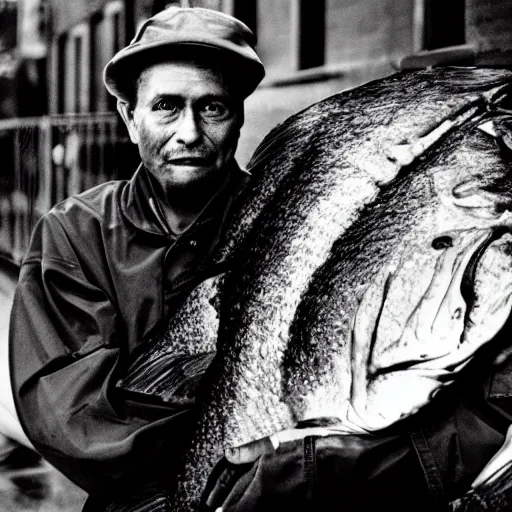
[10,214,196,496]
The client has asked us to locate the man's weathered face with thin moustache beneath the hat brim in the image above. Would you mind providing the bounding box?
[120,62,242,188]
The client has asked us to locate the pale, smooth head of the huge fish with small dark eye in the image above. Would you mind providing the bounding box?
[349,111,512,430]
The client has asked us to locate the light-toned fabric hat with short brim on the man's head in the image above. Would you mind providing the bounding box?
[103,7,265,100]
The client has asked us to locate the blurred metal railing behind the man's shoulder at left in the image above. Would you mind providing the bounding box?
[0,112,138,263]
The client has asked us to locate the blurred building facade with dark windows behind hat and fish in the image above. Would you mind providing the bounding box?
[43,0,512,163]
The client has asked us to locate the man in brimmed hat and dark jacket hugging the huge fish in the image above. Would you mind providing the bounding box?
[10,8,264,511]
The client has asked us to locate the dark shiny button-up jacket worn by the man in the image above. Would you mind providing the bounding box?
[10,165,248,495]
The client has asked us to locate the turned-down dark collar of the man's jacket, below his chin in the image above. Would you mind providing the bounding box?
[121,160,250,236]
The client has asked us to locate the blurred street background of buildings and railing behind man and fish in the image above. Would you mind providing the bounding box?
[0,0,512,512]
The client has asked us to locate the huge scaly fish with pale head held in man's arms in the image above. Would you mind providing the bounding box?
[110,68,512,511]
